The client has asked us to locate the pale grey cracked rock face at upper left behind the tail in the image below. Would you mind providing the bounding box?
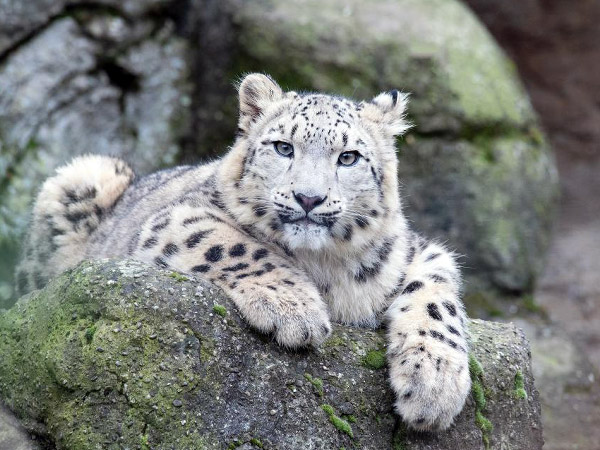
[0,1,190,306]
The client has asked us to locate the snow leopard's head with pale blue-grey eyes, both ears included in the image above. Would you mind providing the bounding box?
[223,75,406,250]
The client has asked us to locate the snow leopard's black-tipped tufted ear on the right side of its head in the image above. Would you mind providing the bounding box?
[362,90,412,136]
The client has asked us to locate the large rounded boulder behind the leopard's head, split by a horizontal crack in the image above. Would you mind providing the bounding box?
[219,0,558,293]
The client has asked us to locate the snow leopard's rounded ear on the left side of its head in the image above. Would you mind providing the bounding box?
[238,73,283,133]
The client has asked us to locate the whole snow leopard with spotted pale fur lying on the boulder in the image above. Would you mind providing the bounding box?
[16,73,471,430]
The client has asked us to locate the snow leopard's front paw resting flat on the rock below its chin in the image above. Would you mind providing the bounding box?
[236,285,331,348]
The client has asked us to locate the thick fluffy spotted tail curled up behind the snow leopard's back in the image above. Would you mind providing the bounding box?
[16,155,134,295]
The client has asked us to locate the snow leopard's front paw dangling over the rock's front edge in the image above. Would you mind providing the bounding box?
[388,344,471,431]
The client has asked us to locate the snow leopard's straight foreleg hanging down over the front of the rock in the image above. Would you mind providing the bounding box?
[387,235,471,430]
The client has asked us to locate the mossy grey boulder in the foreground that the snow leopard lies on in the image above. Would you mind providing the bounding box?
[0,261,542,450]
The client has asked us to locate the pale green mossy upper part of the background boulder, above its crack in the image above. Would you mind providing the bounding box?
[232,0,534,131]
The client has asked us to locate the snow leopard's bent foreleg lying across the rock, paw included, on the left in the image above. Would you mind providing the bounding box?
[129,204,331,347]
